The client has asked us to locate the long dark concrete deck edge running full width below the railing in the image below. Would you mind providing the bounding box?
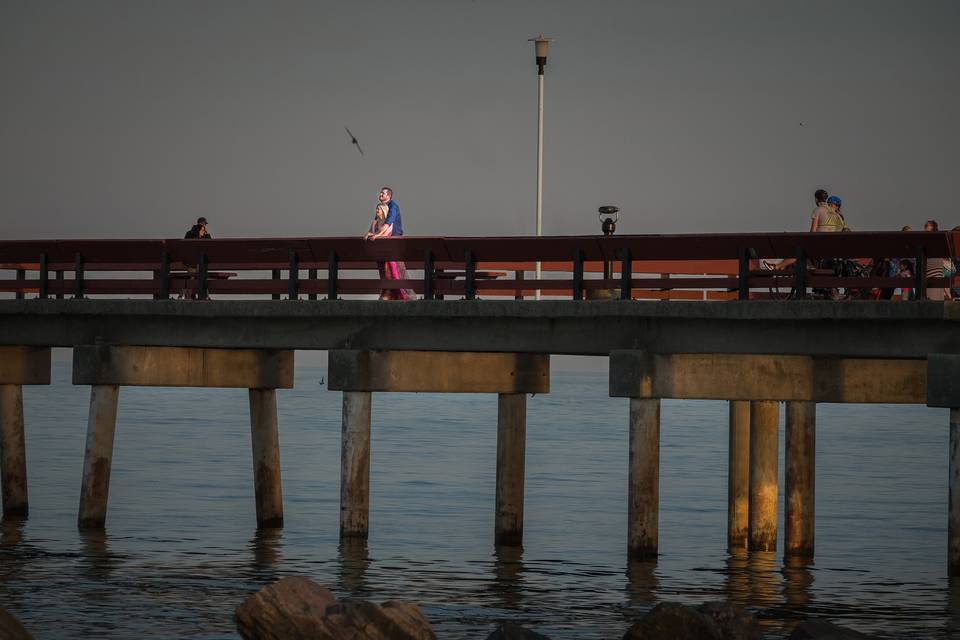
[0,299,960,360]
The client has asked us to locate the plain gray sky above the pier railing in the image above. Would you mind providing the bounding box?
[0,0,960,238]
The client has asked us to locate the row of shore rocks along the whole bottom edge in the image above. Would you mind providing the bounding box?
[0,577,871,640]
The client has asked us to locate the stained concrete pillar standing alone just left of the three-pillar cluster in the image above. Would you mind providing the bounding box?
[627,398,660,558]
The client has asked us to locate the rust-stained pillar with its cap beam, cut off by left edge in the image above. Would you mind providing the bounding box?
[0,346,50,518]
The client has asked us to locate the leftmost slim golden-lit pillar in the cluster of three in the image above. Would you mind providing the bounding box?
[727,400,750,551]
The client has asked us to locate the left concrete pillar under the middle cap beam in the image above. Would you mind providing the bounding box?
[340,391,371,538]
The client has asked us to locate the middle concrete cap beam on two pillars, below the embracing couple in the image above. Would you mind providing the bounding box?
[327,350,550,393]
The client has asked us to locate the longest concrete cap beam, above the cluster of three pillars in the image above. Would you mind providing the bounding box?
[610,350,927,404]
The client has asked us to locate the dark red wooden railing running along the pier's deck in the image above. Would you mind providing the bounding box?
[0,232,960,300]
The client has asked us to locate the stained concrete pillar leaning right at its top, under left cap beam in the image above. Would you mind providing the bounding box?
[77,384,120,529]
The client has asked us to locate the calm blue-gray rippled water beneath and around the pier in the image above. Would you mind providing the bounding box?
[0,360,960,639]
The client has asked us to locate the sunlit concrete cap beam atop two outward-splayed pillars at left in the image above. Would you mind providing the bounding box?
[73,345,293,389]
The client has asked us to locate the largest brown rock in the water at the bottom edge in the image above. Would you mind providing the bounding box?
[235,577,436,640]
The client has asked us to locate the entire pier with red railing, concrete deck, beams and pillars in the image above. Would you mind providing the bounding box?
[0,233,960,575]
